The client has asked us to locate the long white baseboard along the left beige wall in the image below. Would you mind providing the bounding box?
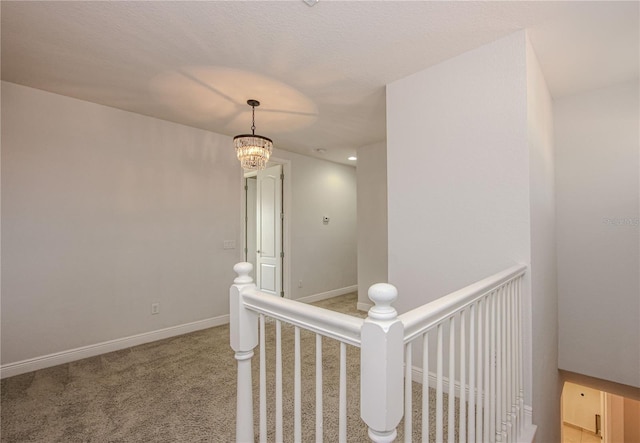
[0,315,229,378]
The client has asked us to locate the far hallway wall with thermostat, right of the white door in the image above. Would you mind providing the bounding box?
[273,149,357,299]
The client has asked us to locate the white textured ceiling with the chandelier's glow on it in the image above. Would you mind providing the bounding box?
[0,0,640,163]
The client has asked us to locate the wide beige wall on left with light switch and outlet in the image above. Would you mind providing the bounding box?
[2,82,241,365]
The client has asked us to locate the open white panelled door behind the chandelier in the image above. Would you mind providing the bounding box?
[256,165,283,297]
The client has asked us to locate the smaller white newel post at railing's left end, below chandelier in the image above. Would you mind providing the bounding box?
[229,262,258,442]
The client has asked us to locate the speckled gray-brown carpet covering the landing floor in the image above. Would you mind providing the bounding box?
[0,294,460,443]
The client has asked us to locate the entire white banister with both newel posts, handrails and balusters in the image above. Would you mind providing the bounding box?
[230,263,535,443]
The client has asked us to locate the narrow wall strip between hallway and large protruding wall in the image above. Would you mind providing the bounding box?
[356,142,389,308]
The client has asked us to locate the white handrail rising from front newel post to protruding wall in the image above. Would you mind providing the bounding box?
[398,265,527,344]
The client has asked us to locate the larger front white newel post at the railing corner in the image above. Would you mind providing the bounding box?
[360,283,404,443]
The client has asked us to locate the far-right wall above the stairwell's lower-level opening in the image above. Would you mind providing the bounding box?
[554,81,640,387]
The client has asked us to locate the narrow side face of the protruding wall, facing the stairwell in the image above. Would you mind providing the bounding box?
[527,39,562,442]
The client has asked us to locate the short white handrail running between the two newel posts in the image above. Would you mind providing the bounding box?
[242,287,364,347]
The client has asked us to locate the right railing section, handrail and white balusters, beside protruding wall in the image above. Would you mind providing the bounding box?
[398,265,527,443]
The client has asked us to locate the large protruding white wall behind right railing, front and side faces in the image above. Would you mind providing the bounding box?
[387,32,560,441]
